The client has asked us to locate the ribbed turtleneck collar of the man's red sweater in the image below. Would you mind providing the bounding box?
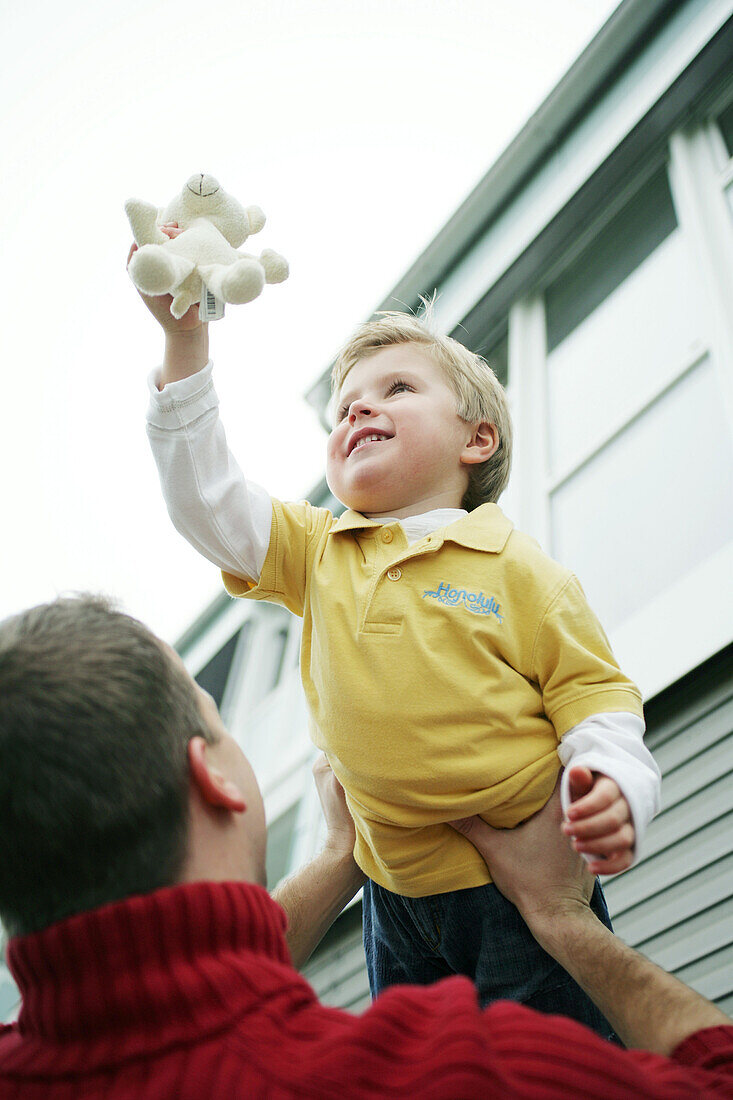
[8,882,294,1065]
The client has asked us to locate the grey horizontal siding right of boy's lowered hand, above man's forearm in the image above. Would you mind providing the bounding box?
[604,649,733,1013]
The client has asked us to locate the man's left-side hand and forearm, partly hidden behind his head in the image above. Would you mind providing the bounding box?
[272,755,364,968]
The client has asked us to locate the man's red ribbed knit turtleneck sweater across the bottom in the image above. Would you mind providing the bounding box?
[0,882,733,1100]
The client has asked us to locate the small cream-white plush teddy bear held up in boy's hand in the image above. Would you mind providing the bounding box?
[124,174,288,318]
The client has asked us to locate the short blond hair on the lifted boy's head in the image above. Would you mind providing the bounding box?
[331,299,512,512]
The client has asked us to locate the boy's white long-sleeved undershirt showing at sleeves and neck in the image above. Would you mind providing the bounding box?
[147,362,660,858]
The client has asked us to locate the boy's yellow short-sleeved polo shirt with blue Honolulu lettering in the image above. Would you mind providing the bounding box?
[225,501,642,898]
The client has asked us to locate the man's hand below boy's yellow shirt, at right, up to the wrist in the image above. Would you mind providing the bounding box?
[450,784,595,938]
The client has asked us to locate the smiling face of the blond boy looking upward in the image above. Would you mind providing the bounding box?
[326,344,473,519]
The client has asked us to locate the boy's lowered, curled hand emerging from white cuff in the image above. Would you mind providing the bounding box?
[562,768,636,875]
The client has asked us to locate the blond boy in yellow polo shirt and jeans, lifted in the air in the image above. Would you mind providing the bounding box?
[137,253,658,1035]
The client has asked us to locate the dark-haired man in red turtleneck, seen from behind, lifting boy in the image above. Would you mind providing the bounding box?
[0,597,733,1100]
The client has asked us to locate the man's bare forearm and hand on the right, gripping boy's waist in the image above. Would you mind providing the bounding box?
[453,791,731,1055]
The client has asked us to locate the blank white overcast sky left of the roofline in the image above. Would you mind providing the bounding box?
[0,0,616,640]
